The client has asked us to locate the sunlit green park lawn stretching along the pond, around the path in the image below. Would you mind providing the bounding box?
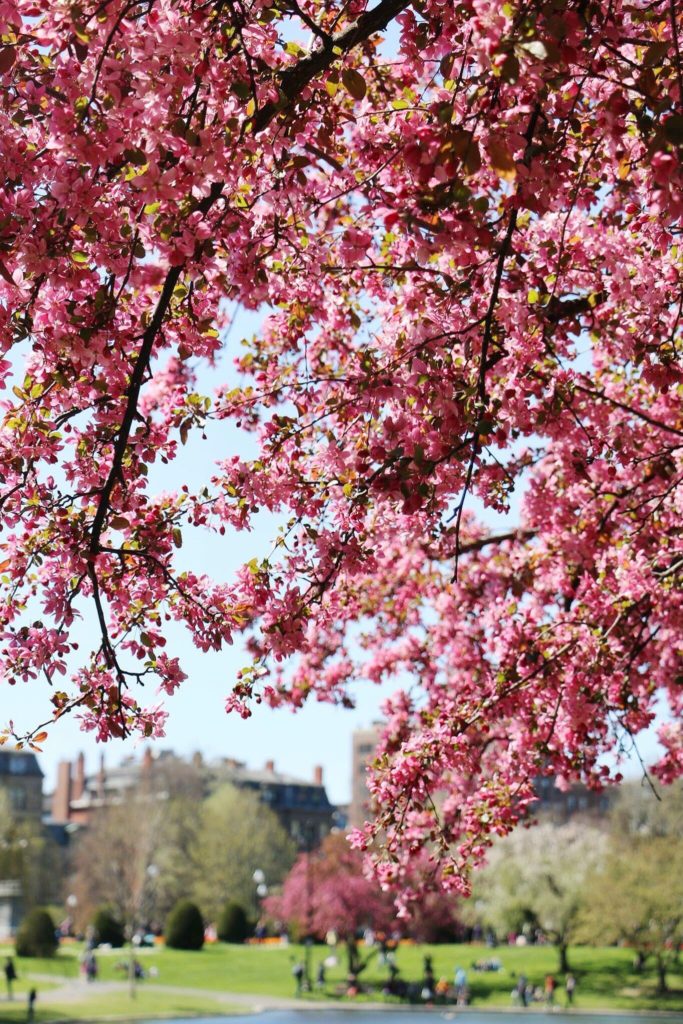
[0,943,683,1022]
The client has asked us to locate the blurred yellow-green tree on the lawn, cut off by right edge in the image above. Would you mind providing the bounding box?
[579,836,683,993]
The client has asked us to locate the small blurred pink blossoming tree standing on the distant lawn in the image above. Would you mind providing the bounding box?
[265,835,395,974]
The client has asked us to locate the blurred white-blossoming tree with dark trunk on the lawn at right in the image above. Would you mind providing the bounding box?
[470,821,607,973]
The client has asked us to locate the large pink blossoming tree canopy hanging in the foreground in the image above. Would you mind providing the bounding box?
[0,0,683,888]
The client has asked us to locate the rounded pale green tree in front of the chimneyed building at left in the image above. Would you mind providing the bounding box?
[190,785,296,921]
